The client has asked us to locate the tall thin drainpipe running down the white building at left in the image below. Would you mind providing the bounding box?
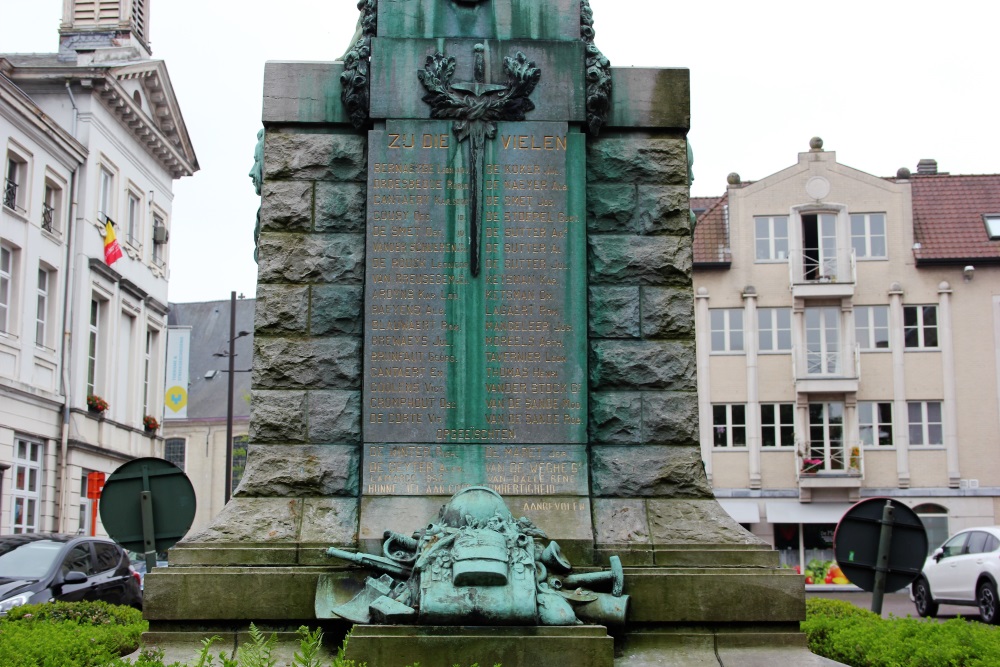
[59,81,80,533]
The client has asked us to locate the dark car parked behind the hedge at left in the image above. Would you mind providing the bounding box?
[0,533,142,615]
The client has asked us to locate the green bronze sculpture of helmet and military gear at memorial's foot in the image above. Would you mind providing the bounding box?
[316,487,629,626]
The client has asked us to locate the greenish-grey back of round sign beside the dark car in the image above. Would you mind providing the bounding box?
[101,458,195,569]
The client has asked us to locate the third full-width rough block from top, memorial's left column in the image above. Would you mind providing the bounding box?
[252,336,361,389]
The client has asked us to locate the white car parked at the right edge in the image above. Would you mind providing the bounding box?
[910,526,1000,624]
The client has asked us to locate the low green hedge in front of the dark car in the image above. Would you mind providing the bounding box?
[0,602,147,667]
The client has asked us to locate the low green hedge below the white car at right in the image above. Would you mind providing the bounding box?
[801,598,1000,667]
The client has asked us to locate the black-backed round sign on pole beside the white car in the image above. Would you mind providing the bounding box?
[833,498,927,592]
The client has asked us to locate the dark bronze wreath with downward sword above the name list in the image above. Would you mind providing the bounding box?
[417,44,542,277]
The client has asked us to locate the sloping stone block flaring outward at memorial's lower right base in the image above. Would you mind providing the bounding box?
[646,497,767,547]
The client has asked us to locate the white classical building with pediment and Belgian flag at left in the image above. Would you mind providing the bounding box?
[0,0,198,533]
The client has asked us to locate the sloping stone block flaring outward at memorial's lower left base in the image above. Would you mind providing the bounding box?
[184,498,302,544]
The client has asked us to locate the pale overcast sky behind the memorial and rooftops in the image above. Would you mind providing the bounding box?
[0,0,1000,302]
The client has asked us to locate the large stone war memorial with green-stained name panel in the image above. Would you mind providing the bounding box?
[145,0,832,667]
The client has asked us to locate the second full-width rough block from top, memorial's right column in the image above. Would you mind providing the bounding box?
[588,234,691,287]
